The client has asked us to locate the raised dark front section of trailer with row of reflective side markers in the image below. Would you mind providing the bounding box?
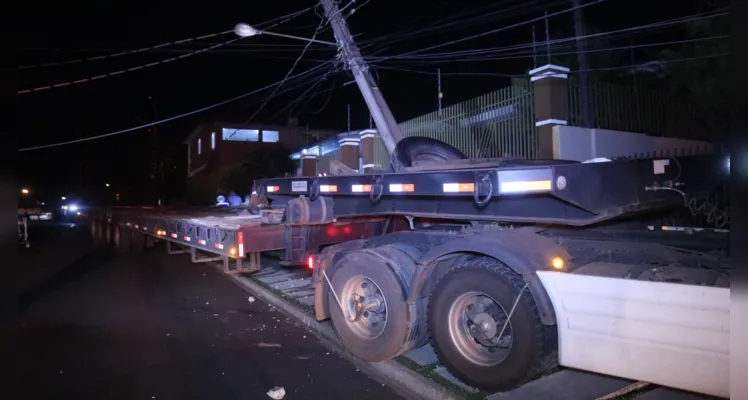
[256,156,729,226]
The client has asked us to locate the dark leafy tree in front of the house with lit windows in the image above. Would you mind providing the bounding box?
[222,144,296,195]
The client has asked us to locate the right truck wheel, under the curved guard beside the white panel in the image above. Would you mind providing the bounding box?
[428,257,558,391]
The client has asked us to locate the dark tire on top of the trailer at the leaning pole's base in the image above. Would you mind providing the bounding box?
[390,136,467,172]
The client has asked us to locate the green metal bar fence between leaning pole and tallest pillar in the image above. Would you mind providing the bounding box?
[374,79,537,167]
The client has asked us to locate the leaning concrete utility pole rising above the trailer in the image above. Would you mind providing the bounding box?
[321,0,402,154]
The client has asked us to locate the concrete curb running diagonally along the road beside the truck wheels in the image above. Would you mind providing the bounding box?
[212,264,459,400]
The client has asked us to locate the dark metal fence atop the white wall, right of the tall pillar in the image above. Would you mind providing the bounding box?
[567,77,707,140]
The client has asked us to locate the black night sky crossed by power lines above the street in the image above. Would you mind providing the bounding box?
[16,0,720,205]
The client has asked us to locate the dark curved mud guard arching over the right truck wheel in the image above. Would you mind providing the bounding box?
[408,232,571,325]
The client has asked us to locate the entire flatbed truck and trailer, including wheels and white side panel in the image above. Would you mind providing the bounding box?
[92,152,729,396]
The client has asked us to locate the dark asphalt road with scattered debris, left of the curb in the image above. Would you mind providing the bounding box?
[17,223,399,400]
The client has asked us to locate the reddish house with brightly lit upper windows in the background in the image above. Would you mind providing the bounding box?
[184,120,328,204]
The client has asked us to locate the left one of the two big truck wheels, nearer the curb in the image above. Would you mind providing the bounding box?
[328,246,427,362]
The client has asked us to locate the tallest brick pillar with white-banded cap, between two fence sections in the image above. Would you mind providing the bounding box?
[530,64,569,159]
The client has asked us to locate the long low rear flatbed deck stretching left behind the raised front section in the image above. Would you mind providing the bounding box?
[93,207,384,272]
